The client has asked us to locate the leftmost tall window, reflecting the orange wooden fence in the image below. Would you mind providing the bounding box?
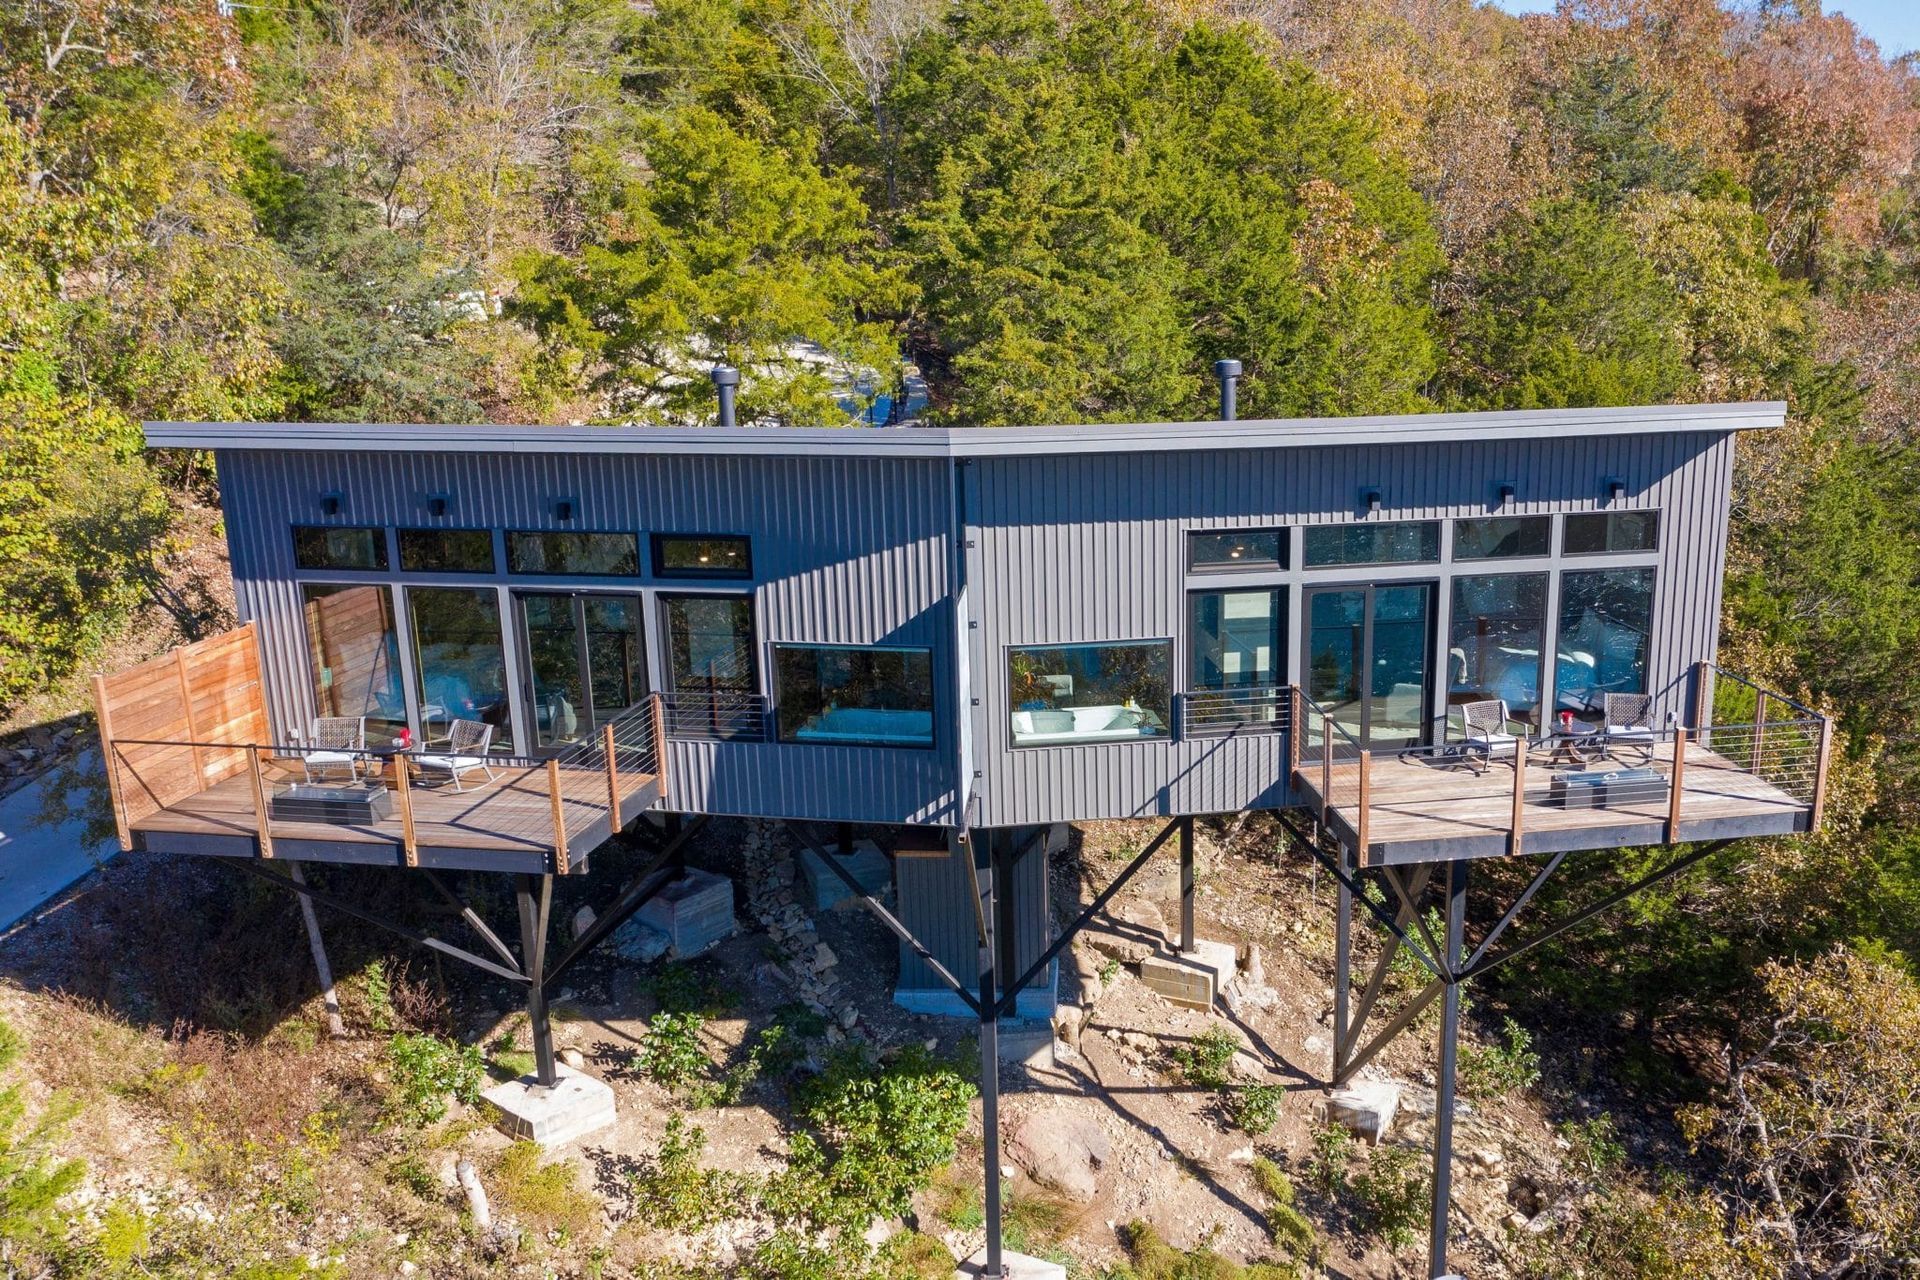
[300,583,407,745]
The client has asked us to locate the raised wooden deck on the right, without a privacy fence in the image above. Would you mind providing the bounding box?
[1296,741,1814,865]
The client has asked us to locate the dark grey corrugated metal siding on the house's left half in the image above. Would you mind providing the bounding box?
[219,451,954,821]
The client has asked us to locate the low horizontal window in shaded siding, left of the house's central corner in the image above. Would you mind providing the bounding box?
[774,645,933,747]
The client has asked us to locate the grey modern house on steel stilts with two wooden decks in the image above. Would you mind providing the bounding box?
[96,388,1832,1276]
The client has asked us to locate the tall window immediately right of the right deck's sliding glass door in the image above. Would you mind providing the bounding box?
[1446,574,1548,723]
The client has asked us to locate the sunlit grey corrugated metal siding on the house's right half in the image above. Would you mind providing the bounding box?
[968,434,1734,827]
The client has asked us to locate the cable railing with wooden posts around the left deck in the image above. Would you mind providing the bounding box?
[106,695,668,875]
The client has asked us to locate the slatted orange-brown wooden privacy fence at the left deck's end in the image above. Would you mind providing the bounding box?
[94,622,269,850]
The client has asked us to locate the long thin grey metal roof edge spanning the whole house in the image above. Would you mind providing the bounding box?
[146,401,1786,459]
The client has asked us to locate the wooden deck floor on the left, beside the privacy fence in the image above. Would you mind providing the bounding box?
[131,764,660,871]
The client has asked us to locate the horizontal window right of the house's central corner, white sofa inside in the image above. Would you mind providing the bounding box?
[1006,641,1173,745]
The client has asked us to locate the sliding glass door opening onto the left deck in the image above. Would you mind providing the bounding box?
[515,591,647,752]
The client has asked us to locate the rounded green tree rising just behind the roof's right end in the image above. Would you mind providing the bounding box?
[1444,200,1690,409]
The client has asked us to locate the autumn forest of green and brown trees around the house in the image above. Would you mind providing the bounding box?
[0,0,1920,1276]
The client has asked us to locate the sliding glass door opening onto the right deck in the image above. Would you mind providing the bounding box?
[1306,581,1434,747]
